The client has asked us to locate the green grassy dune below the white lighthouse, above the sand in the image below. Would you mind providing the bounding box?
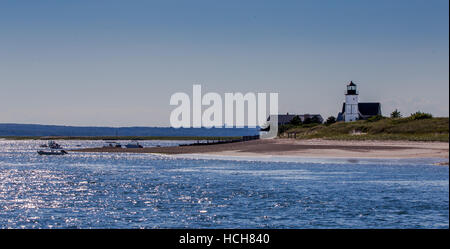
[280,116,449,142]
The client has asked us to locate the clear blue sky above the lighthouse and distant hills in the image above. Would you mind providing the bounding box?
[0,0,449,126]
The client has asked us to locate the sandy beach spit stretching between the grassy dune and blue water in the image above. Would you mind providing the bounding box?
[74,139,449,159]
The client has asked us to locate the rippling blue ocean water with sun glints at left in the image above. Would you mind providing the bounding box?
[0,140,449,228]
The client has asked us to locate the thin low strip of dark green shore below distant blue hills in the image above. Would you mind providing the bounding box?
[0,136,242,140]
